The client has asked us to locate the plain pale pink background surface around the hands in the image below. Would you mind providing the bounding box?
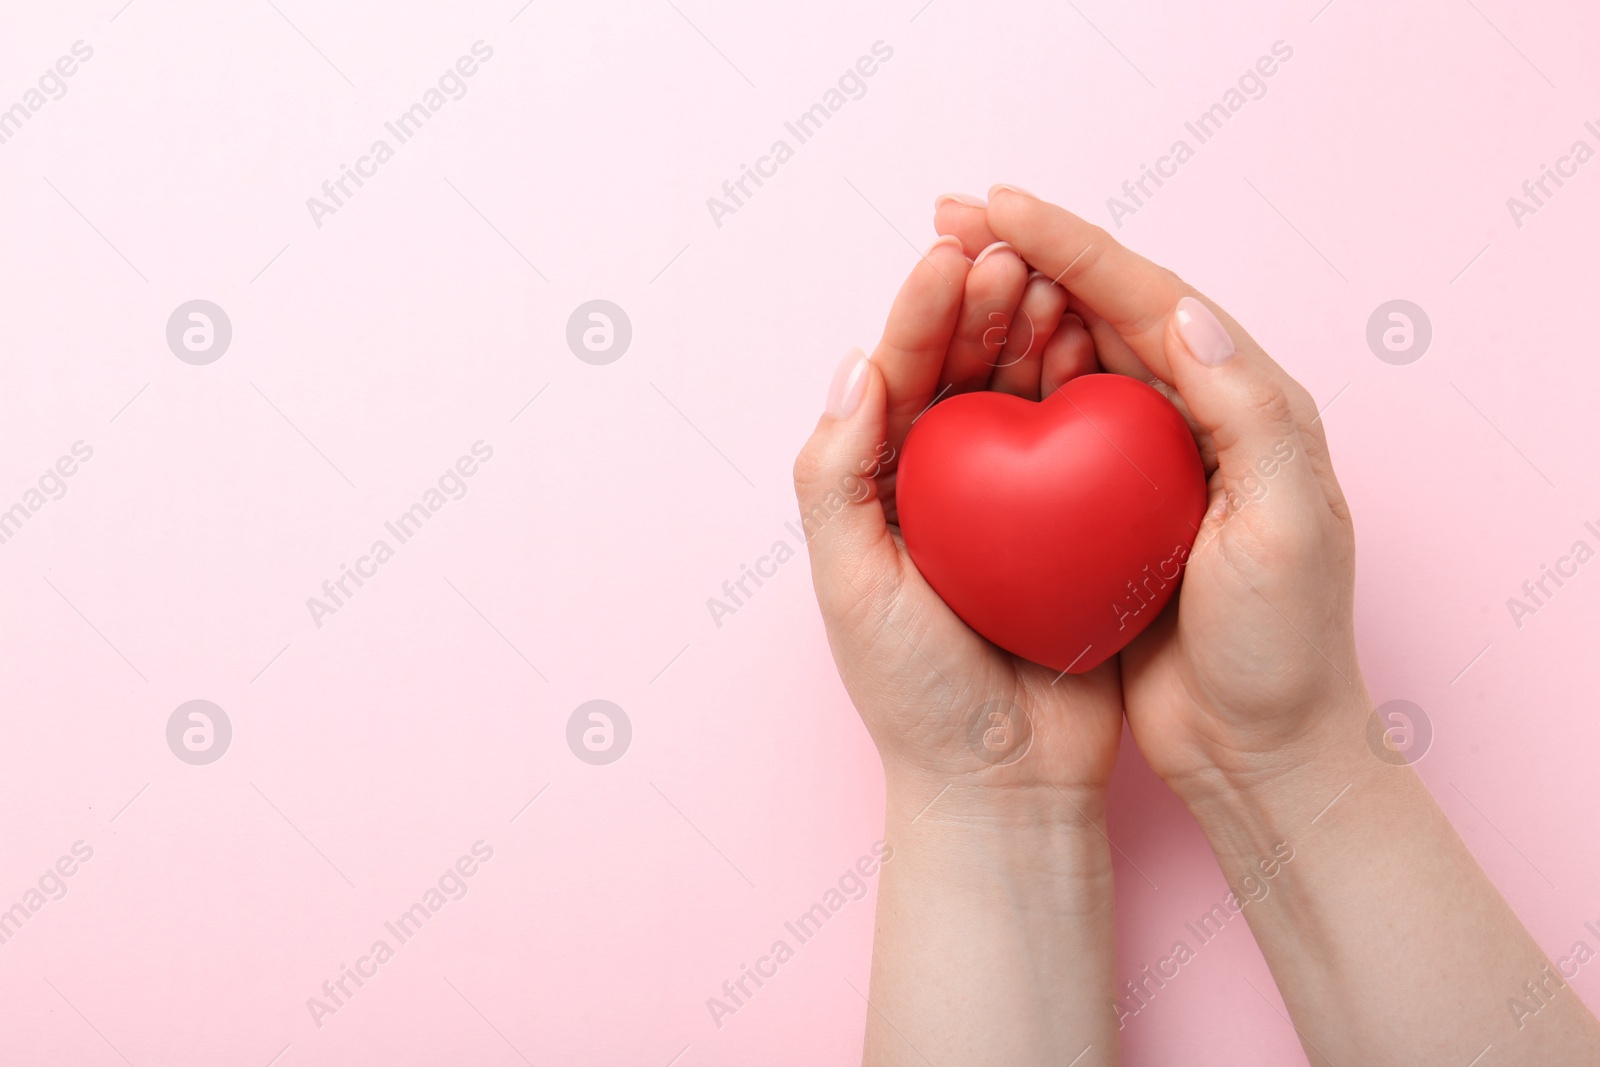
[0,0,1600,1067]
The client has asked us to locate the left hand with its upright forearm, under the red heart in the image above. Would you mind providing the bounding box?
[795,231,1122,1067]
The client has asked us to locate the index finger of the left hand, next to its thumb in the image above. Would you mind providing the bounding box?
[872,237,970,467]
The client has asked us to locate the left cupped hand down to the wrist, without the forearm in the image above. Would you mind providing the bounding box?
[795,231,1122,803]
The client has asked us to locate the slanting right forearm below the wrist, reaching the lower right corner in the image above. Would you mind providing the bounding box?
[1190,700,1600,1067]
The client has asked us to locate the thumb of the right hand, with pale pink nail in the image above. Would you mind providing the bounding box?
[1165,296,1320,501]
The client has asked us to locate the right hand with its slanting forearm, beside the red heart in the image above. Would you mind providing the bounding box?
[939,187,1600,1067]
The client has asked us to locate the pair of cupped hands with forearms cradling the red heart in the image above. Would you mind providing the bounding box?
[795,187,1600,1067]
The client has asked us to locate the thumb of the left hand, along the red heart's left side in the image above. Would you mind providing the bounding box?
[794,349,899,619]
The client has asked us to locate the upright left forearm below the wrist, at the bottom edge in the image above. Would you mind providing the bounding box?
[864,774,1117,1067]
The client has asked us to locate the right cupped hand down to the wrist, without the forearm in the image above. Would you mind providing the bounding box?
[936,186,1371,797]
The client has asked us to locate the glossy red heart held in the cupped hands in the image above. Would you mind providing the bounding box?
[894,374,1206,673]
